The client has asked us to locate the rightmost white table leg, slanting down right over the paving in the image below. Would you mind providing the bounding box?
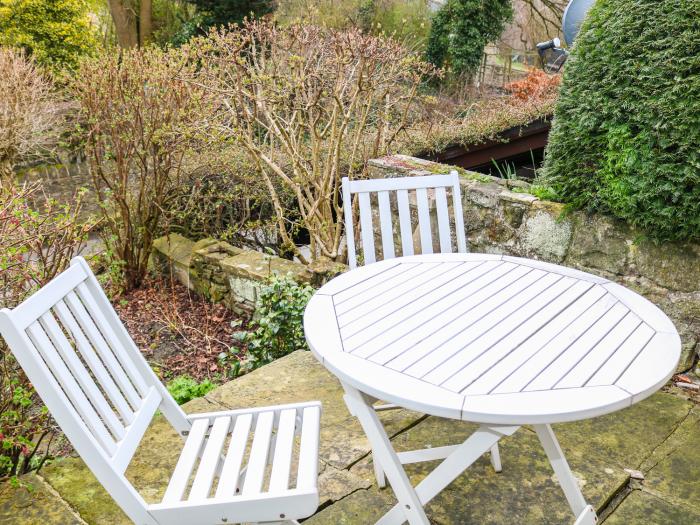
[533,425,598,525]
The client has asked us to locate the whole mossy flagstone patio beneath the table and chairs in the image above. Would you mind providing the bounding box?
[0,352,700,525]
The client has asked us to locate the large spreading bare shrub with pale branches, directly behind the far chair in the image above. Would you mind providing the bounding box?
[198,21,435,262]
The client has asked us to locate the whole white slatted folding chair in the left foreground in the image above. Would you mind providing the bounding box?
[0,257,321,525]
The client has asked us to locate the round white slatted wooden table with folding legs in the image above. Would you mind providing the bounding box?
[304,254,681,525]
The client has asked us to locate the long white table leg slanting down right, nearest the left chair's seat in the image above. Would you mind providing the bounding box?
[343,383,430,525]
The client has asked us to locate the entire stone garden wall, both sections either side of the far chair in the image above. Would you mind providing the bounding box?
[154,155,700,371]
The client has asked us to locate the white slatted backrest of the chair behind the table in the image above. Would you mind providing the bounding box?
[343,171,467,268]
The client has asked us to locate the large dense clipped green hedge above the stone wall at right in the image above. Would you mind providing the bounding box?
[544,0,700,241]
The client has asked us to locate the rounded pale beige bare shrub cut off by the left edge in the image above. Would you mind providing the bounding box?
[0,47,62,185]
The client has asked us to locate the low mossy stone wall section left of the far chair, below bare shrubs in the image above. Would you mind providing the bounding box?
[153,234,346,314]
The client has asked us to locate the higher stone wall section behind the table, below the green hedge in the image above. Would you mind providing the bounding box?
[370,155,700,371]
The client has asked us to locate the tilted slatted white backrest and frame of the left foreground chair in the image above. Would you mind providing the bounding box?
[0,257,191,523]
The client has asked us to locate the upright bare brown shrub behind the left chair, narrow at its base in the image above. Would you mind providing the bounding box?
[72,44,213,289]
